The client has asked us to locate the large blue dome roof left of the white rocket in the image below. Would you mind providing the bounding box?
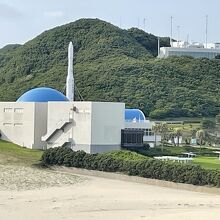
[17,87,68,102]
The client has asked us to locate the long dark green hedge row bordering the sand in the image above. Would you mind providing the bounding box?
[42,147,220,187]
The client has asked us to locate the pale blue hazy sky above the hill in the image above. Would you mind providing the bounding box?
[0,0,220,48]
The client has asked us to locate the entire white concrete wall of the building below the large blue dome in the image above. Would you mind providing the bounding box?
[0,102,125,153]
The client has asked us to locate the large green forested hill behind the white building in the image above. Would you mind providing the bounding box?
[0,19,220,118]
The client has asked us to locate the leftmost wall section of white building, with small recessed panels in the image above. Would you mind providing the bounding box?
[0,102,47,149]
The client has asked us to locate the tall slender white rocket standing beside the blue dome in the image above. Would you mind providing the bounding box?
[66,42,74,101]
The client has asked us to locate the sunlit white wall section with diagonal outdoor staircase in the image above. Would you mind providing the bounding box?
[47,102,91,153]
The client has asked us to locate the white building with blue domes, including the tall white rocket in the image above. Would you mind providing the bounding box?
[0,43,161,153]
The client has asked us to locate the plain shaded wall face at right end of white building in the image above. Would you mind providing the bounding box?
[91,102,125,153]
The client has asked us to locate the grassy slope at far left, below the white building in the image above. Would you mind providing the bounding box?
[0,140,43,166]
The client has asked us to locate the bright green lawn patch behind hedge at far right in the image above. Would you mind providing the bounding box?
[193,156,220,170]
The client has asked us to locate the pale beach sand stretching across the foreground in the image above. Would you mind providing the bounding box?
[0,167,220,220]
